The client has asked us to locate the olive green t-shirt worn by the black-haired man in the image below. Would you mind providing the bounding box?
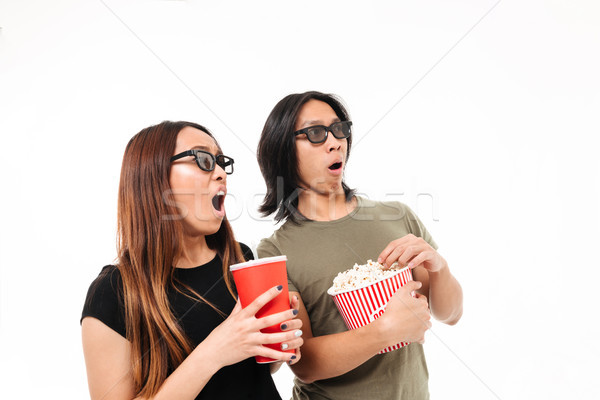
[257,196,437,400]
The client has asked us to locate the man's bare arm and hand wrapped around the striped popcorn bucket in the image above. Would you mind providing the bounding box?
[291,282,431,383]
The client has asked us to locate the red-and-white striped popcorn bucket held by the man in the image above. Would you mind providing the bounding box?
[327,267,414,354]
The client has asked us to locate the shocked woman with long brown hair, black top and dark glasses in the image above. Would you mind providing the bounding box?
[82,121,302,399]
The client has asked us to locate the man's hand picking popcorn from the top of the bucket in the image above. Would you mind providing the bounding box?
[377,234,448,272]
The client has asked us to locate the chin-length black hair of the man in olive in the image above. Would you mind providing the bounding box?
[256,91,355,222]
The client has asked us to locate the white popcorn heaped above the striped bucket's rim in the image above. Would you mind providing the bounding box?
[328,260,401,293]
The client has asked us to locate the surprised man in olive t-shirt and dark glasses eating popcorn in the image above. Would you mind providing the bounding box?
[257,92,462,400]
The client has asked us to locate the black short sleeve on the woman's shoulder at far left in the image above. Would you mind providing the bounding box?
[80,265,127,338]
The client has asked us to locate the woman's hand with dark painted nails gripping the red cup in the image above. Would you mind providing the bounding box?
[203,286,302,366]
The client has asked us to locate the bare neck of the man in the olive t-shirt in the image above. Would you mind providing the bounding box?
[298,189,356,221]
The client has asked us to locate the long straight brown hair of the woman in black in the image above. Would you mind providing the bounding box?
[117,121,244,397]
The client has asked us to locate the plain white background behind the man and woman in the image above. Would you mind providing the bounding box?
[0,0,600,399]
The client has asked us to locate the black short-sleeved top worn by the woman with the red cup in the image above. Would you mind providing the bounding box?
[81,244,281,400]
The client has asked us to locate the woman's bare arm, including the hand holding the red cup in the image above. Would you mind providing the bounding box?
[82,288,302,400]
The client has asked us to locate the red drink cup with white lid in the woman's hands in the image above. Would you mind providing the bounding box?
[229,256,295,364]
